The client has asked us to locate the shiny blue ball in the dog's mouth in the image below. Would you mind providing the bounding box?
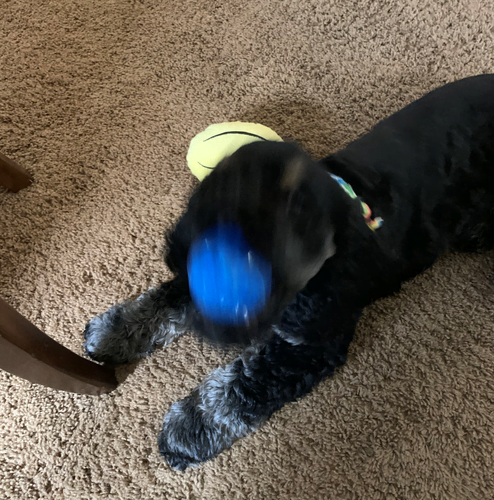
[187,224,271,326]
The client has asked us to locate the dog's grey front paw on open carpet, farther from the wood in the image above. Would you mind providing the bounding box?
[158,396,234,472]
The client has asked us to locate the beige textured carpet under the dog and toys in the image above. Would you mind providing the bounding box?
[0,0,494,500]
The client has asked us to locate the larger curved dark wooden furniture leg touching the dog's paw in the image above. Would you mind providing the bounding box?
[0,298,118,395]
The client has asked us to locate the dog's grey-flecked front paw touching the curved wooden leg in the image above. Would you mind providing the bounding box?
[84,304,142,365]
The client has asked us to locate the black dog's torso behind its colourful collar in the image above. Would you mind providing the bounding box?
[324,75,494,295]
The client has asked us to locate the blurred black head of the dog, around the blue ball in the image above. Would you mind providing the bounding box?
[167,142,348,343]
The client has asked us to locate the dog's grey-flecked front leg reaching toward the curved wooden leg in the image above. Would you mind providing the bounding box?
[84,280,190,365]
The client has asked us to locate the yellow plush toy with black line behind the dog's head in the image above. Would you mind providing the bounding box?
[187,122,283,181]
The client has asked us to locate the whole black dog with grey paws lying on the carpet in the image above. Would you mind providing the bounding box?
[86,75,494,470]
